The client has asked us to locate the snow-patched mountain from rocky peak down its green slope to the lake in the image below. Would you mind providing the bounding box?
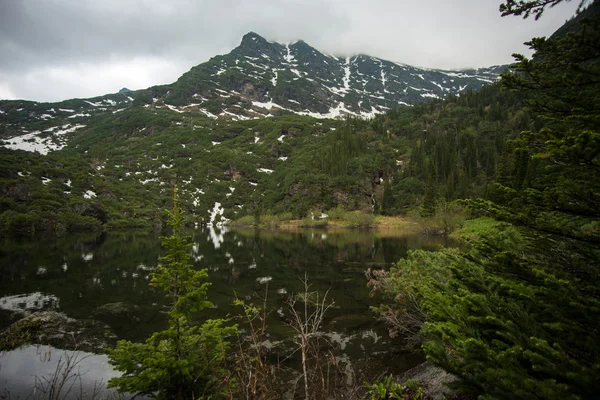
[0,33,506,233]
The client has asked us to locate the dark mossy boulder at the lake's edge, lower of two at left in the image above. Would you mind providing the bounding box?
[0,311,117,353]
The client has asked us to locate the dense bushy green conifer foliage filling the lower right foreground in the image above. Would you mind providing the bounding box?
[378,222,600,399]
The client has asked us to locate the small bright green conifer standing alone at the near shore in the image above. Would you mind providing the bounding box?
[107,192,236,399]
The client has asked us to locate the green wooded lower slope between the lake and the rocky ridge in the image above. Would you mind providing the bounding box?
[0,81,533,232]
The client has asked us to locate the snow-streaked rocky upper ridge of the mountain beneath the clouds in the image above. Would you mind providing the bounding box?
[0,32,506,133]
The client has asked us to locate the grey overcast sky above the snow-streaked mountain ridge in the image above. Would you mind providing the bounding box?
[0,0,578,101]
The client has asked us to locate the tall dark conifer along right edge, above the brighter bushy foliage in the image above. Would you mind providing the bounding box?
[492,0,600,240]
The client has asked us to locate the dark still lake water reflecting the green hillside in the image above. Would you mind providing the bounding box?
[0,228,446,396]
